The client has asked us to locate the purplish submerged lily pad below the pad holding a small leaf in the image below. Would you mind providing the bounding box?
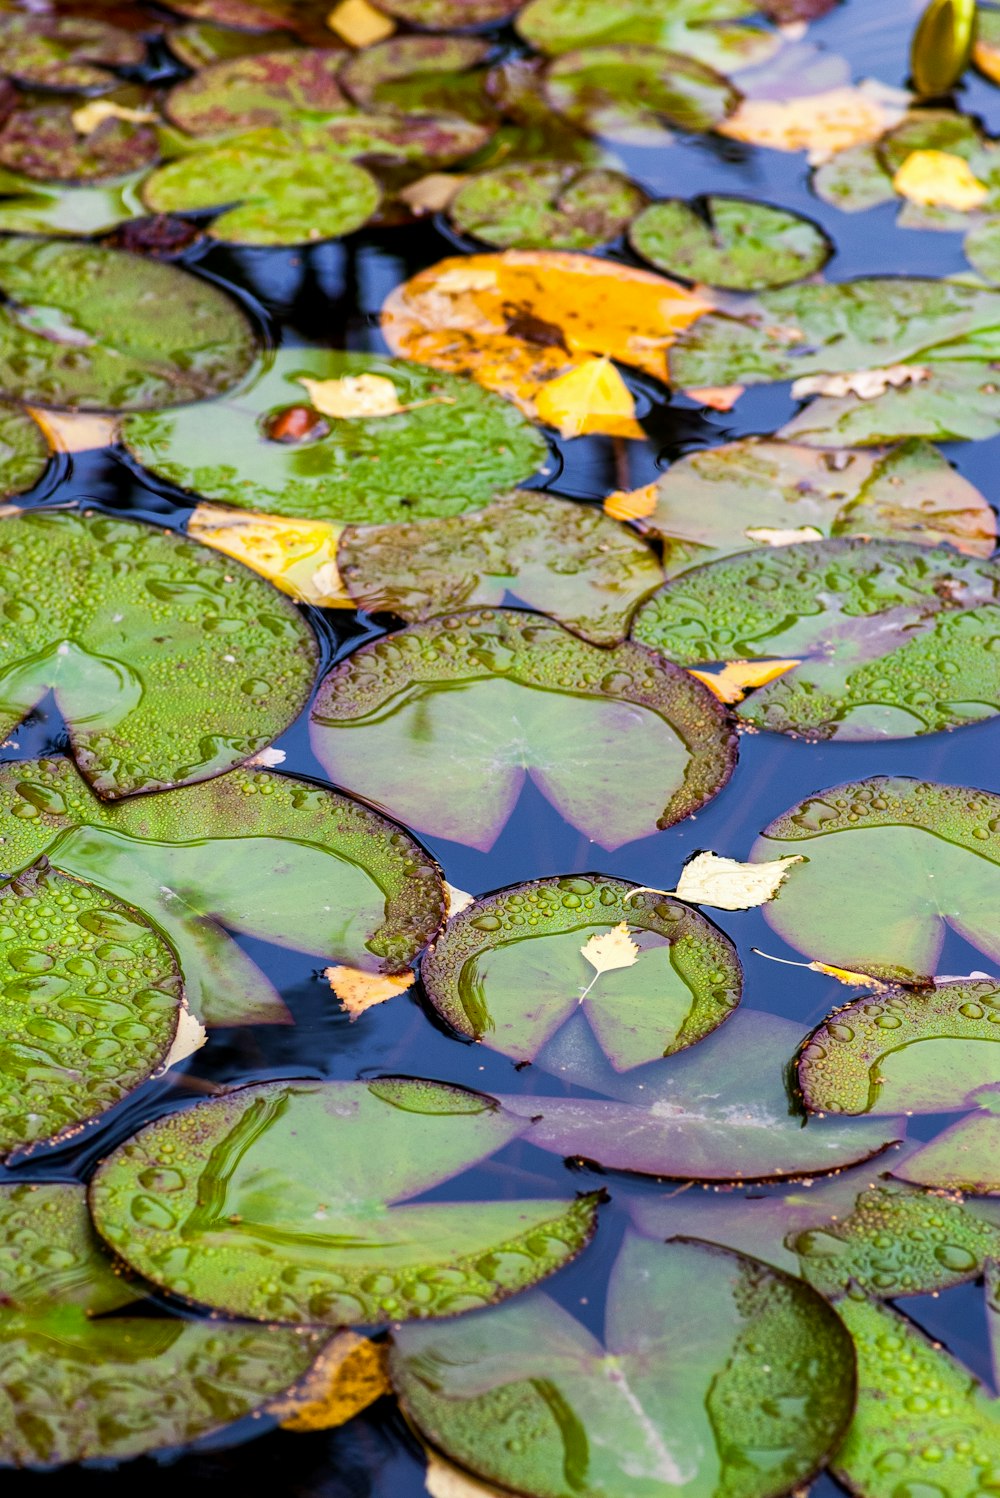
[503,1007,906,1182]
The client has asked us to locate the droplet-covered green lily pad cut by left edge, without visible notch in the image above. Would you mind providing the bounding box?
[0,860,181,1155]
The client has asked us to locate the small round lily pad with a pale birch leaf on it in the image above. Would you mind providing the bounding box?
[421,875,743,1072]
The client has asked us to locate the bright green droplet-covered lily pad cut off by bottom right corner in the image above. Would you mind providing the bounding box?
[832,1296,1000,1498]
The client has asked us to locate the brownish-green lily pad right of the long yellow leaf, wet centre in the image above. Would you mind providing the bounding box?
[337,490,663,646]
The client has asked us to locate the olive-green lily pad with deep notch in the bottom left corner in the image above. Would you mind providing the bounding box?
[0,1180,323,1468]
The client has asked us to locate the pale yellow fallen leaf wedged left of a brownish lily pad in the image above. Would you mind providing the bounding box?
[187,505,355,608]
